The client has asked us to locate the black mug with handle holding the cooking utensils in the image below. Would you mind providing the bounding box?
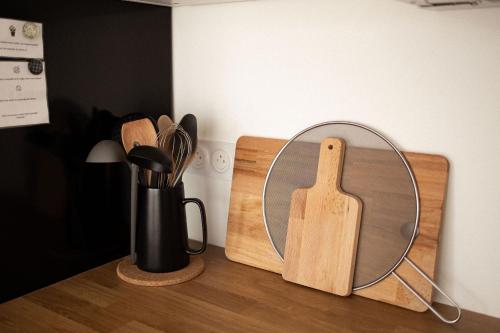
[136,183,207,273]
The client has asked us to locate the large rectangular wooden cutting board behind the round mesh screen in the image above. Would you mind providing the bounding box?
[226,136,448,312]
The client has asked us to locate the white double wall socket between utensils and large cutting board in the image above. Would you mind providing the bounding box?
[186,140,236,181]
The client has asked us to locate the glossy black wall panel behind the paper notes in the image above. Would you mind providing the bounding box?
[0,0,172,302]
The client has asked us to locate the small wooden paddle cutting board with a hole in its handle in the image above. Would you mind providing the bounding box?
[282,138,362,296]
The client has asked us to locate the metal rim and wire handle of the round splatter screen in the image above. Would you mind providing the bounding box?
[262,121,462,324]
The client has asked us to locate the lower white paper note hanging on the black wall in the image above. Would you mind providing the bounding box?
[0,61,49,127]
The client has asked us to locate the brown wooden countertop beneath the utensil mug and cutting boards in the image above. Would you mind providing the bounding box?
[0,246,500,333]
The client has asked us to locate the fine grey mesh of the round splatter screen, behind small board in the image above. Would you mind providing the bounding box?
[263,123,417,289]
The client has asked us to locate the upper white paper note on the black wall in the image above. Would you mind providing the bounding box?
[0,19,43,59]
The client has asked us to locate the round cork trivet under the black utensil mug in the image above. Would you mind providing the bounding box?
[116,256,205,287]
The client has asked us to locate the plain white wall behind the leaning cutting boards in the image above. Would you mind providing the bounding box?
[173,0,500,317]
